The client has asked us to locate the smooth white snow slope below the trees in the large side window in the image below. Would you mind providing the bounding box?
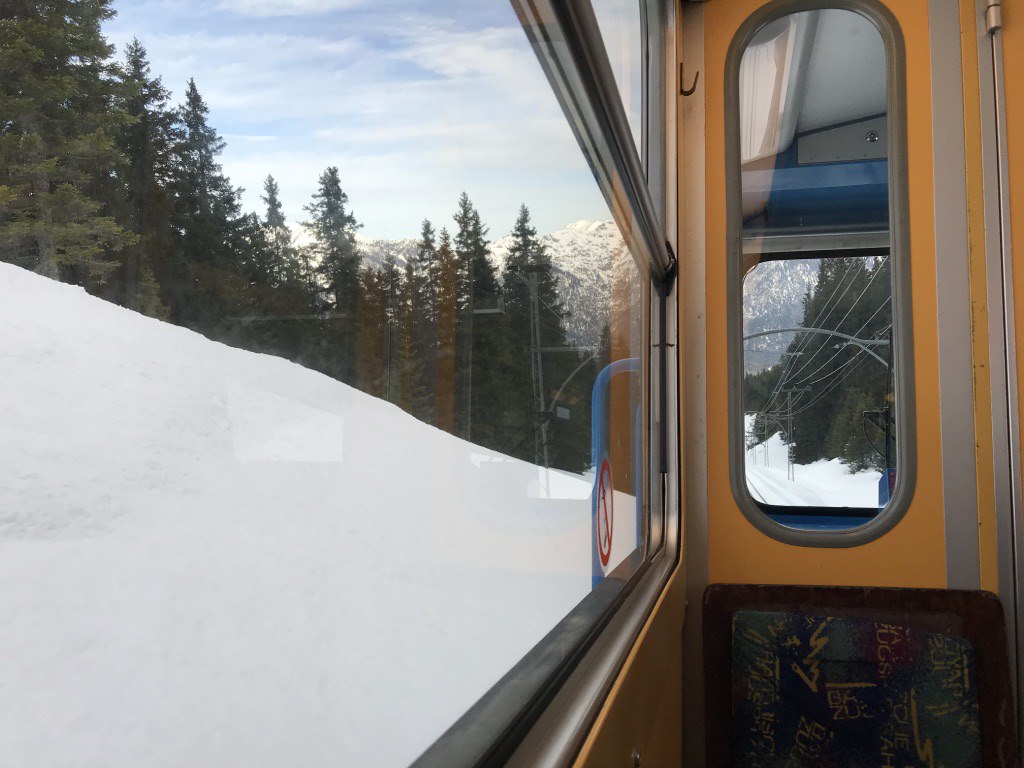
[0,264,635,768]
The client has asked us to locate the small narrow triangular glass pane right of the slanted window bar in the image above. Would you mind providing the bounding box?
[592,0,644,152]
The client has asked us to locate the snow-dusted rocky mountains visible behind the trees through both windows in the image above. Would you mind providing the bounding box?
[359,221,817,358]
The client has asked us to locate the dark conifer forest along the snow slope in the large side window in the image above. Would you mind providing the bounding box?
[0,0,608,471]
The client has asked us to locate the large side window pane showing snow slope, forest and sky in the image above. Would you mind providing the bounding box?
[0,0,648,767]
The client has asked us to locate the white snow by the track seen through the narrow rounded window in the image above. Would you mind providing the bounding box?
[746,416,882,507]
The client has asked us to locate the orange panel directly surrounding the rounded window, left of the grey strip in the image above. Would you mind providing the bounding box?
[703,0,946,587]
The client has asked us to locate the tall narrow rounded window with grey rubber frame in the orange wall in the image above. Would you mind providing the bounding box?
[732,4,910,541]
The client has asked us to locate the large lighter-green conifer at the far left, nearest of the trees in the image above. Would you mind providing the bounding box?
[0,0,134,288]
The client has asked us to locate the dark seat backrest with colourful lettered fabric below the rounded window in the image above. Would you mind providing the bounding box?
[703,585,1018,768]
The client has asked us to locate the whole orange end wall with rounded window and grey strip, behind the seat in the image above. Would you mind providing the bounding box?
[680,0,1019,765]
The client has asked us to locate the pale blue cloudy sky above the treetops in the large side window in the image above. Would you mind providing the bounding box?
[105,0,630,238]
